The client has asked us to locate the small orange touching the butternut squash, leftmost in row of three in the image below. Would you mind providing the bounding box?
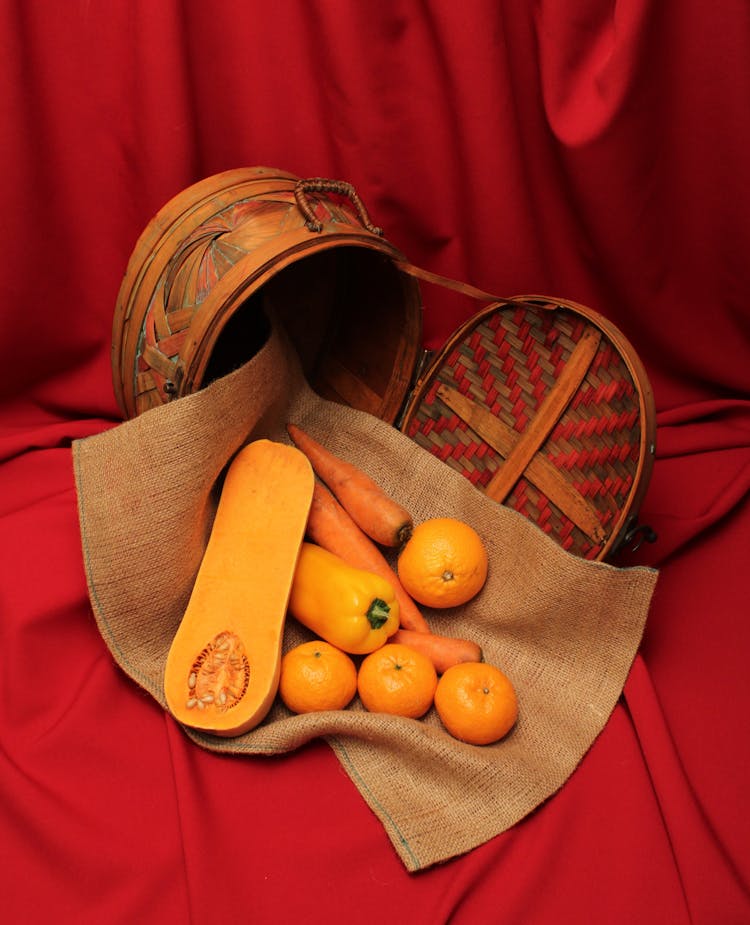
[279,639,357,713]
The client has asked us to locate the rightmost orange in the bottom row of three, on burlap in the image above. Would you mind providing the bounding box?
[435,662,518,745]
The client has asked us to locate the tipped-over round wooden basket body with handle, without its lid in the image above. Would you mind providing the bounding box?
[112,167,422,421]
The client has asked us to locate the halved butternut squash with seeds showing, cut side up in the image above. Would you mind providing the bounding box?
[164,439,314,736]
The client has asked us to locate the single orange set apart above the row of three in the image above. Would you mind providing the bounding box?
[397,517,487,608]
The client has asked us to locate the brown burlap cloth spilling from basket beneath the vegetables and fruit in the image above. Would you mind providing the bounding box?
[73,322,656,871]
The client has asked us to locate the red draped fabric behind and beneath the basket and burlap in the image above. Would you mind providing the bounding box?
[0,0,750,925]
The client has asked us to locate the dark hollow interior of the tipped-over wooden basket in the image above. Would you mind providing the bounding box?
[203,246,421,421]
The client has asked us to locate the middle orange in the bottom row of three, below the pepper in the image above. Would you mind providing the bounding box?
[357,642,437,719]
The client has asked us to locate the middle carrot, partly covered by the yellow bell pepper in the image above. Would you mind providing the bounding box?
[307,482,430,633]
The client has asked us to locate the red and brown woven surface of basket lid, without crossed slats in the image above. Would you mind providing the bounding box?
[407,303,641,559]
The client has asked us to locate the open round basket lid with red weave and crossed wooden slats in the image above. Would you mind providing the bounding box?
[401,296,655,560]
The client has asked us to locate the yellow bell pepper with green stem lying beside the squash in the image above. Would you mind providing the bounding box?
[289,542,406,655]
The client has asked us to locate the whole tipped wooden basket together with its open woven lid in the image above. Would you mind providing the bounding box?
[112,167,655,559]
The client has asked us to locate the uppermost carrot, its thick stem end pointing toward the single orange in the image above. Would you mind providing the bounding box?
[286,424,414,546]
